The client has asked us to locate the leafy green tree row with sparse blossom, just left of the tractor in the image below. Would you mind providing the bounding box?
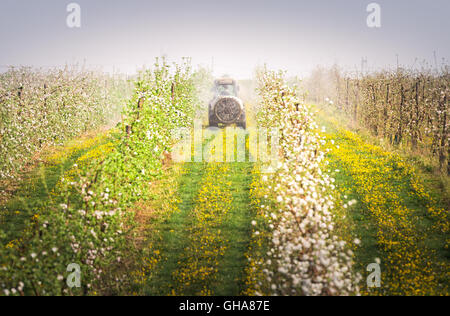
[0,60,195,295]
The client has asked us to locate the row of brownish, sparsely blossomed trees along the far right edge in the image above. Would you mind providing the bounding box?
[306,66,450,173]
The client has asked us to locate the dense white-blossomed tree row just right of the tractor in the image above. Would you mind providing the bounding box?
[244,70,360,295]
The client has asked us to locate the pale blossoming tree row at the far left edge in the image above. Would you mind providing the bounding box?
[0,67,129,179]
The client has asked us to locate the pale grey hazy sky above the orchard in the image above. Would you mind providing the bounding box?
[0,0,450,78]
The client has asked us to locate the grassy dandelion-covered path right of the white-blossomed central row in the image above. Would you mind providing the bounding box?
[319,106,449,295]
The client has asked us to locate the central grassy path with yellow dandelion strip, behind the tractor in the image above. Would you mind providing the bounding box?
[144,127,253,295]
